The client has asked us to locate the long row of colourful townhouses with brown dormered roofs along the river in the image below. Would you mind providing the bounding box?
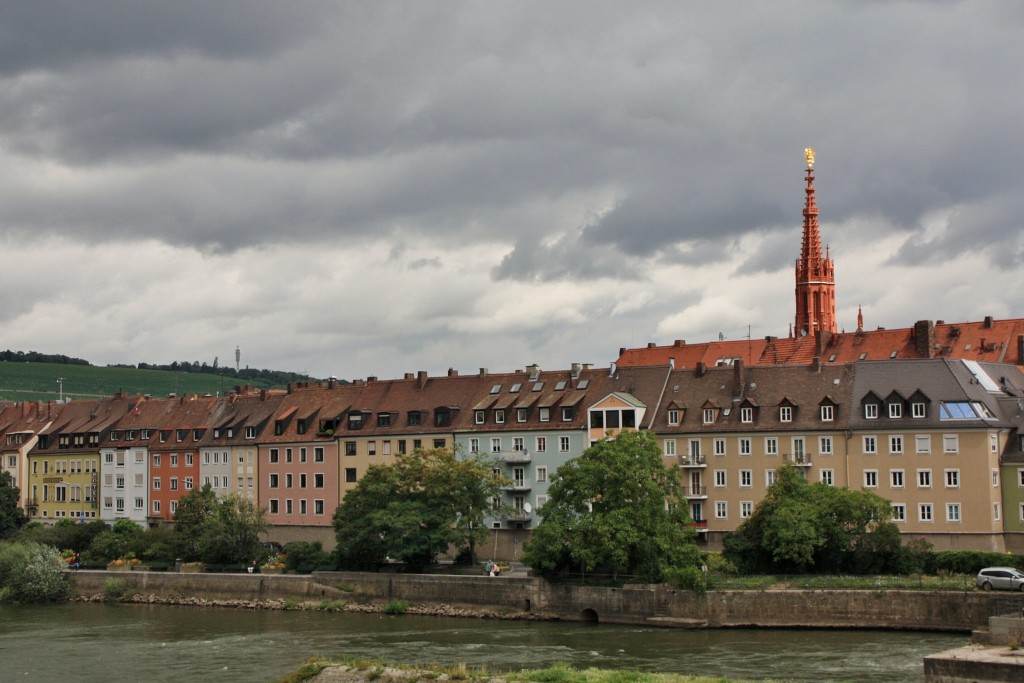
[0,359,1024,556]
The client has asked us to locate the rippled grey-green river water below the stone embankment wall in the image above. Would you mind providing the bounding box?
[0,603,970,683]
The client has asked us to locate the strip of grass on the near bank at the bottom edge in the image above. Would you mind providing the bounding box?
[280,656,770,683]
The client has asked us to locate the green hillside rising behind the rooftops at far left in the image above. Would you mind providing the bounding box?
[0,361,305,401]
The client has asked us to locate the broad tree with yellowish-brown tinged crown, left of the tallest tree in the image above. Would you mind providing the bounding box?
[334,449,504,571]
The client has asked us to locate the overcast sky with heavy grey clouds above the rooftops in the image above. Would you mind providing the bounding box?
[0,0,1024,379]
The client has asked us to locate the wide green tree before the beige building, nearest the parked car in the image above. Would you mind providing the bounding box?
[725,465,900,573]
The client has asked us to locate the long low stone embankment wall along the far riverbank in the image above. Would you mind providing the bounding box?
[72,571,1007,632]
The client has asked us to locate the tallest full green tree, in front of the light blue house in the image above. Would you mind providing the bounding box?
[523,432,699,582]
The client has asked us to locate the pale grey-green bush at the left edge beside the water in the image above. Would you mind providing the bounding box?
[0,542,71,603]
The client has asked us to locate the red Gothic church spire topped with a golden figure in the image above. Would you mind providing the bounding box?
[796,147,836,336]
